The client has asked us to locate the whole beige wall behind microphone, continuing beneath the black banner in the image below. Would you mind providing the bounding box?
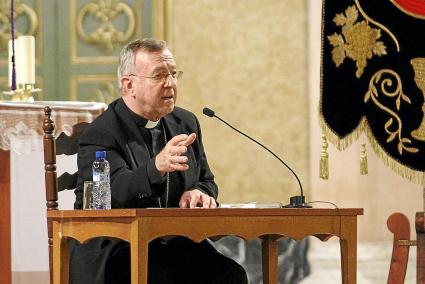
[173,0,422,241]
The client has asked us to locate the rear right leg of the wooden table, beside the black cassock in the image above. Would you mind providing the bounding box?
[261,235,278,284]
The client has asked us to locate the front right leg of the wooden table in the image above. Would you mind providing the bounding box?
[339,217,357,284]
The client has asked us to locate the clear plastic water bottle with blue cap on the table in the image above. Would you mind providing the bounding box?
[92,151,111,209]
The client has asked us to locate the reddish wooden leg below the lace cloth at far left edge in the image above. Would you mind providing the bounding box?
[0,150,12,283]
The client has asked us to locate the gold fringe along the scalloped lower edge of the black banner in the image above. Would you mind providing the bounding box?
[319,113,425,187]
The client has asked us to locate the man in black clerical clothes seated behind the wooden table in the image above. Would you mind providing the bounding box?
[70,39,248,284]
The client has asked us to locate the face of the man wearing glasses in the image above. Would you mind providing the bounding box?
[131,49,177,121]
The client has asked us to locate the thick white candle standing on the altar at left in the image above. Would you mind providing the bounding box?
[15,36,35,84]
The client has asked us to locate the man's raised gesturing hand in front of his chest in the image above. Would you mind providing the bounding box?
[155,133,196,175]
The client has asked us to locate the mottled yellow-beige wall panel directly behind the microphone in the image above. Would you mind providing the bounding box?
[173,0,309,203]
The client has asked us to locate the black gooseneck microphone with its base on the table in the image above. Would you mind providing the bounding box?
[202,107,311,208]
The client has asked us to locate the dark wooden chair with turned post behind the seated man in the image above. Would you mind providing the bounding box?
[43,106,89,283]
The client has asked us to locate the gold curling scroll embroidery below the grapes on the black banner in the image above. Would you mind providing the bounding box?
[364,69,419,155]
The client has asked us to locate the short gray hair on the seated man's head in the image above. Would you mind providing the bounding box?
[117,38,168,90]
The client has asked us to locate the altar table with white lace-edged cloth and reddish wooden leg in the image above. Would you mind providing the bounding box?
[0,101,106,283]
